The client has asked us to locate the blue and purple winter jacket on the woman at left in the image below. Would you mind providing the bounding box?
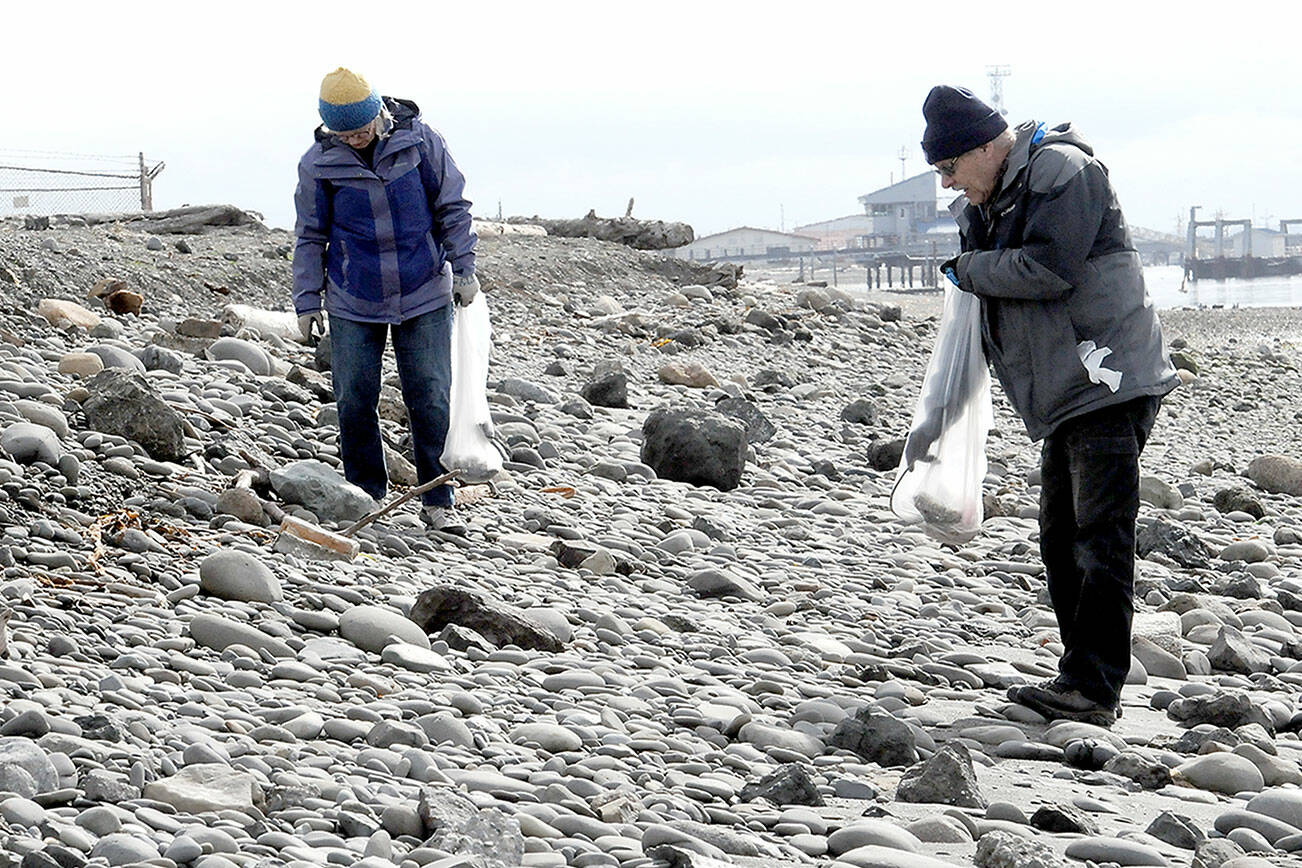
[294,96,477,323]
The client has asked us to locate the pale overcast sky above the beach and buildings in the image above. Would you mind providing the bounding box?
[0,0,1302,236]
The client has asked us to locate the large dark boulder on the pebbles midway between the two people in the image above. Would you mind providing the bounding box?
[642,410,746,491]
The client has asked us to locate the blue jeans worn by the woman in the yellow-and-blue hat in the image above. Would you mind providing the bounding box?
[329,303,453,506]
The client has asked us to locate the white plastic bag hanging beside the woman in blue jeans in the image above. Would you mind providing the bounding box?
[441,293,501,483]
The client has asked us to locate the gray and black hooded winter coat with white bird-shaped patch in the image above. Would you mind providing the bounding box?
[950,121,1180,440]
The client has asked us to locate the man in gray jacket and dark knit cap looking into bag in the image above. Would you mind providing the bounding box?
[910,85,1178,726]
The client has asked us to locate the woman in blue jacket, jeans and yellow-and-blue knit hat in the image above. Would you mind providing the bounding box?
[294,68,479,531]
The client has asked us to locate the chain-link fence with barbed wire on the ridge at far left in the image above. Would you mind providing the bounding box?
[0,150,163,217]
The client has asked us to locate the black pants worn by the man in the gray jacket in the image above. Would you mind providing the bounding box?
[1040,397,1161,703]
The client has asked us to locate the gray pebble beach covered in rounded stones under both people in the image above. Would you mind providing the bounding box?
[0,212,1302,868]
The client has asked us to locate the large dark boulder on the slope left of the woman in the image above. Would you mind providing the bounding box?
[82,368,186,461]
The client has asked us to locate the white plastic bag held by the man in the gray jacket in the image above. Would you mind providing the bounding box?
[891,286,993,541]
